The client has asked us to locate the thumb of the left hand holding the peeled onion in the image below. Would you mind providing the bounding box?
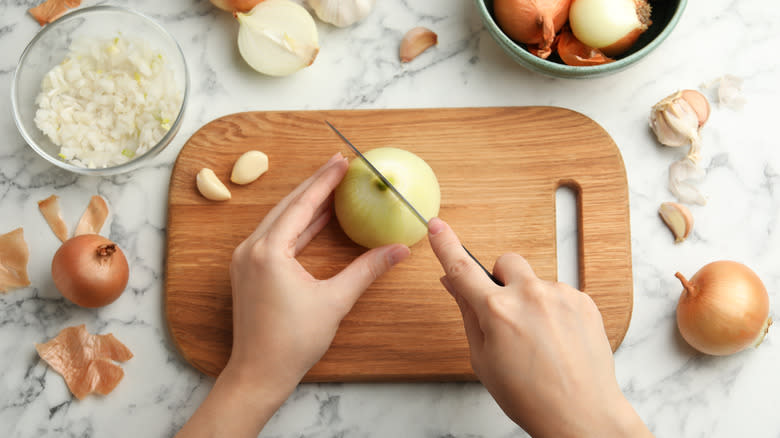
[328,244,411,311]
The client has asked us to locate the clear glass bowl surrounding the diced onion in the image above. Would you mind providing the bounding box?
[11,5,190,175]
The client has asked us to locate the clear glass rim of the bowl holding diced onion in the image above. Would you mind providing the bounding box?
[11,5,190,176]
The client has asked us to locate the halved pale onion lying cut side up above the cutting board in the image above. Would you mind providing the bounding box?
[234,0,320,76]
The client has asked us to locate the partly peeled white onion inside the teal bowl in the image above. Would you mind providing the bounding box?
[569,0,651,57]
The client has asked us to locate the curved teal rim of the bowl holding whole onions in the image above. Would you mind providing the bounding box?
[474,0,688,79]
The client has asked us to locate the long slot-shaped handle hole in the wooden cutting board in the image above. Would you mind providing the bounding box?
[555,184,582,290]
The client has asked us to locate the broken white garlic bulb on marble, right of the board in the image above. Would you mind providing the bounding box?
[650,91,699,147]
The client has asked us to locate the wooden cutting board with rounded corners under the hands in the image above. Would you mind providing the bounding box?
[165,107,633,382]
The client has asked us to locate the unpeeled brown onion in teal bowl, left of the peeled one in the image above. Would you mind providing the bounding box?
[493,0,571,58]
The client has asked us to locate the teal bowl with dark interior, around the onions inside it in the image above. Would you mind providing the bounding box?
[474,0,688,79]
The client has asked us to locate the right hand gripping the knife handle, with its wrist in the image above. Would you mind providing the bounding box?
[428,218,652,437]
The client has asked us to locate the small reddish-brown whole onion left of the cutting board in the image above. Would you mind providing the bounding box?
[51,234,129,307]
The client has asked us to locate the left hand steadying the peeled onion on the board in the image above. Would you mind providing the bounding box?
[228,154,409,391]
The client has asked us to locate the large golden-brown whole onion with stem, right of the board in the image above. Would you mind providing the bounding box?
[676,261,772,356]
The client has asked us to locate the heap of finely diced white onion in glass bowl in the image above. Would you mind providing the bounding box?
[35,35,182,168]
